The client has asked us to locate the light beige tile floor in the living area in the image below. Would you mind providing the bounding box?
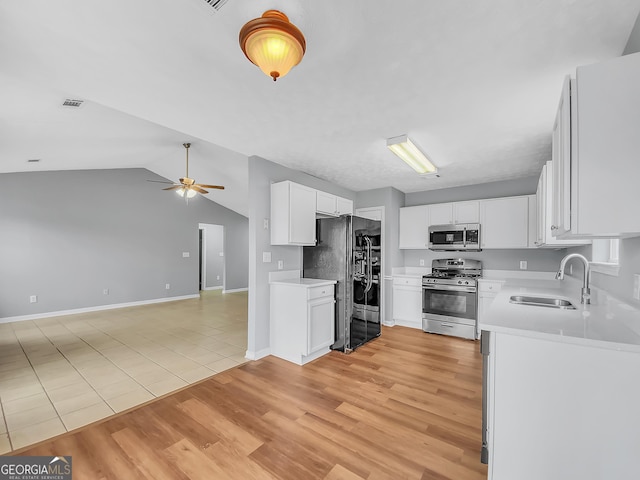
[0,290,247,454]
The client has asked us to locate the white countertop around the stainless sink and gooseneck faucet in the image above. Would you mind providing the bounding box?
[479,277,640,353]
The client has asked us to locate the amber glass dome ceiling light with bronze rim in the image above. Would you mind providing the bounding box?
[240,10,307,82]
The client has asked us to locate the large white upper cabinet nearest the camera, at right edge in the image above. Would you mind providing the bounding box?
[552,53,640,238]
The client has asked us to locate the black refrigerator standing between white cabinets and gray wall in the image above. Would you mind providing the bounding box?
[302,215,382,352]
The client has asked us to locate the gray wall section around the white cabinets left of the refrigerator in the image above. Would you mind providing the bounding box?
[247,156,355,356]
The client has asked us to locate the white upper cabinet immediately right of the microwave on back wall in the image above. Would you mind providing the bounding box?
[480,196,529,248]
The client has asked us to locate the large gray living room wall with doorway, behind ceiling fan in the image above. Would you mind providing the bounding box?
[0,169,248,318]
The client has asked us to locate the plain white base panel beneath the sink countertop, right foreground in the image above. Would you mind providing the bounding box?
[483,332,640,480]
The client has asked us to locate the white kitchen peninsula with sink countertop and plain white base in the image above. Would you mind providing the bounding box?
[480,279,640,480]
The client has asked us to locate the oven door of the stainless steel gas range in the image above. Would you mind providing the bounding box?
[422,285,478,320]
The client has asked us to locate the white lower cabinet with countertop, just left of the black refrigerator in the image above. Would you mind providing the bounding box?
[270,278,335,365]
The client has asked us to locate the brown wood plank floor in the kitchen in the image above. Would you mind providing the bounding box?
[14,327,487,480]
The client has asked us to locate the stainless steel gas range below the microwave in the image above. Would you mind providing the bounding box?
[422,258,482,340]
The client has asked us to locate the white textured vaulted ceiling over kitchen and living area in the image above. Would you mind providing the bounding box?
[0,0,640,215]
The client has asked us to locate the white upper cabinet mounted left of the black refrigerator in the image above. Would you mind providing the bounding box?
[271,181,316,245]
